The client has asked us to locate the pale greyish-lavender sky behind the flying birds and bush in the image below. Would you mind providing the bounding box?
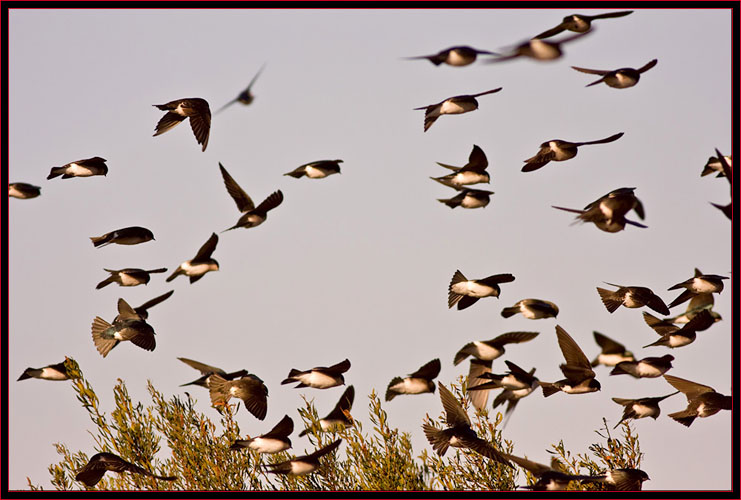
[6,9,737,490]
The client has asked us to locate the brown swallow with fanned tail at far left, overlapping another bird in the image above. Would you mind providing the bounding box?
[92,299,157,358]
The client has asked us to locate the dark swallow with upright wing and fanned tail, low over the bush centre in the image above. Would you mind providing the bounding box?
[422,382,512,467]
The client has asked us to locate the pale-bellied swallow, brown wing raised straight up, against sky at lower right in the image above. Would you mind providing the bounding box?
[540,325,601,397]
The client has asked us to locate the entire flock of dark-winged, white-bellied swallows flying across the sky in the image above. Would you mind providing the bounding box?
[9,11,732,491]
